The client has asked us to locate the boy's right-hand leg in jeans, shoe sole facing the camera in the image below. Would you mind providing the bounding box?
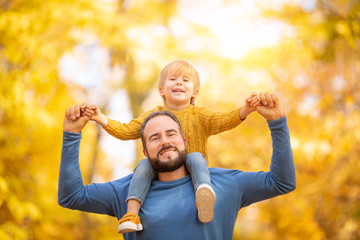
[186,152,215,223]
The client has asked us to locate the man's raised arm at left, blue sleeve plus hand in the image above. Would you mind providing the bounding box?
[58,106,115,216]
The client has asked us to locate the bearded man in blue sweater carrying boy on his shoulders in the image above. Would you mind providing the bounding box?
[59,93,296,239]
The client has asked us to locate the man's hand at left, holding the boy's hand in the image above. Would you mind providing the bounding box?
[63,105,91,133]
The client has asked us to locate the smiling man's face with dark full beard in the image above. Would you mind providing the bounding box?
[144,115,187,172]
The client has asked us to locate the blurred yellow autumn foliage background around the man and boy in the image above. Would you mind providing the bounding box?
[0,0,360,240]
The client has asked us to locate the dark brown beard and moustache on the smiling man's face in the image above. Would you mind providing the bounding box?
[148,146,187,172]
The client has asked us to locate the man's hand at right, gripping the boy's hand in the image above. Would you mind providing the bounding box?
[255,93,285,121]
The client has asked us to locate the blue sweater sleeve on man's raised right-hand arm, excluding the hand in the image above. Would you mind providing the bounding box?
[234,116,296,207]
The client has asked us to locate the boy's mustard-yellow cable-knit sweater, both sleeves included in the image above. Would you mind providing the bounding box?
[105,105,241,159]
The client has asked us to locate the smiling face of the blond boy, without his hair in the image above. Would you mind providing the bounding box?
[159,73,199,110]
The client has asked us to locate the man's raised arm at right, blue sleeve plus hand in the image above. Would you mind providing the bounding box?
[239,93,296,207]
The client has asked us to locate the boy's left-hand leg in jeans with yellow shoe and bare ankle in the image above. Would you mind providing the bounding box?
[118,159,155,233]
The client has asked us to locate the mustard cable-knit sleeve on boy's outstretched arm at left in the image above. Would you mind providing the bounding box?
[105,108,159,140]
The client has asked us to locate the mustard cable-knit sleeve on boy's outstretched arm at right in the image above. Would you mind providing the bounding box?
[198,107,242,136]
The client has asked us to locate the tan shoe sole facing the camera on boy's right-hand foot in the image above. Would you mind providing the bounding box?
[195,188,215,223]
